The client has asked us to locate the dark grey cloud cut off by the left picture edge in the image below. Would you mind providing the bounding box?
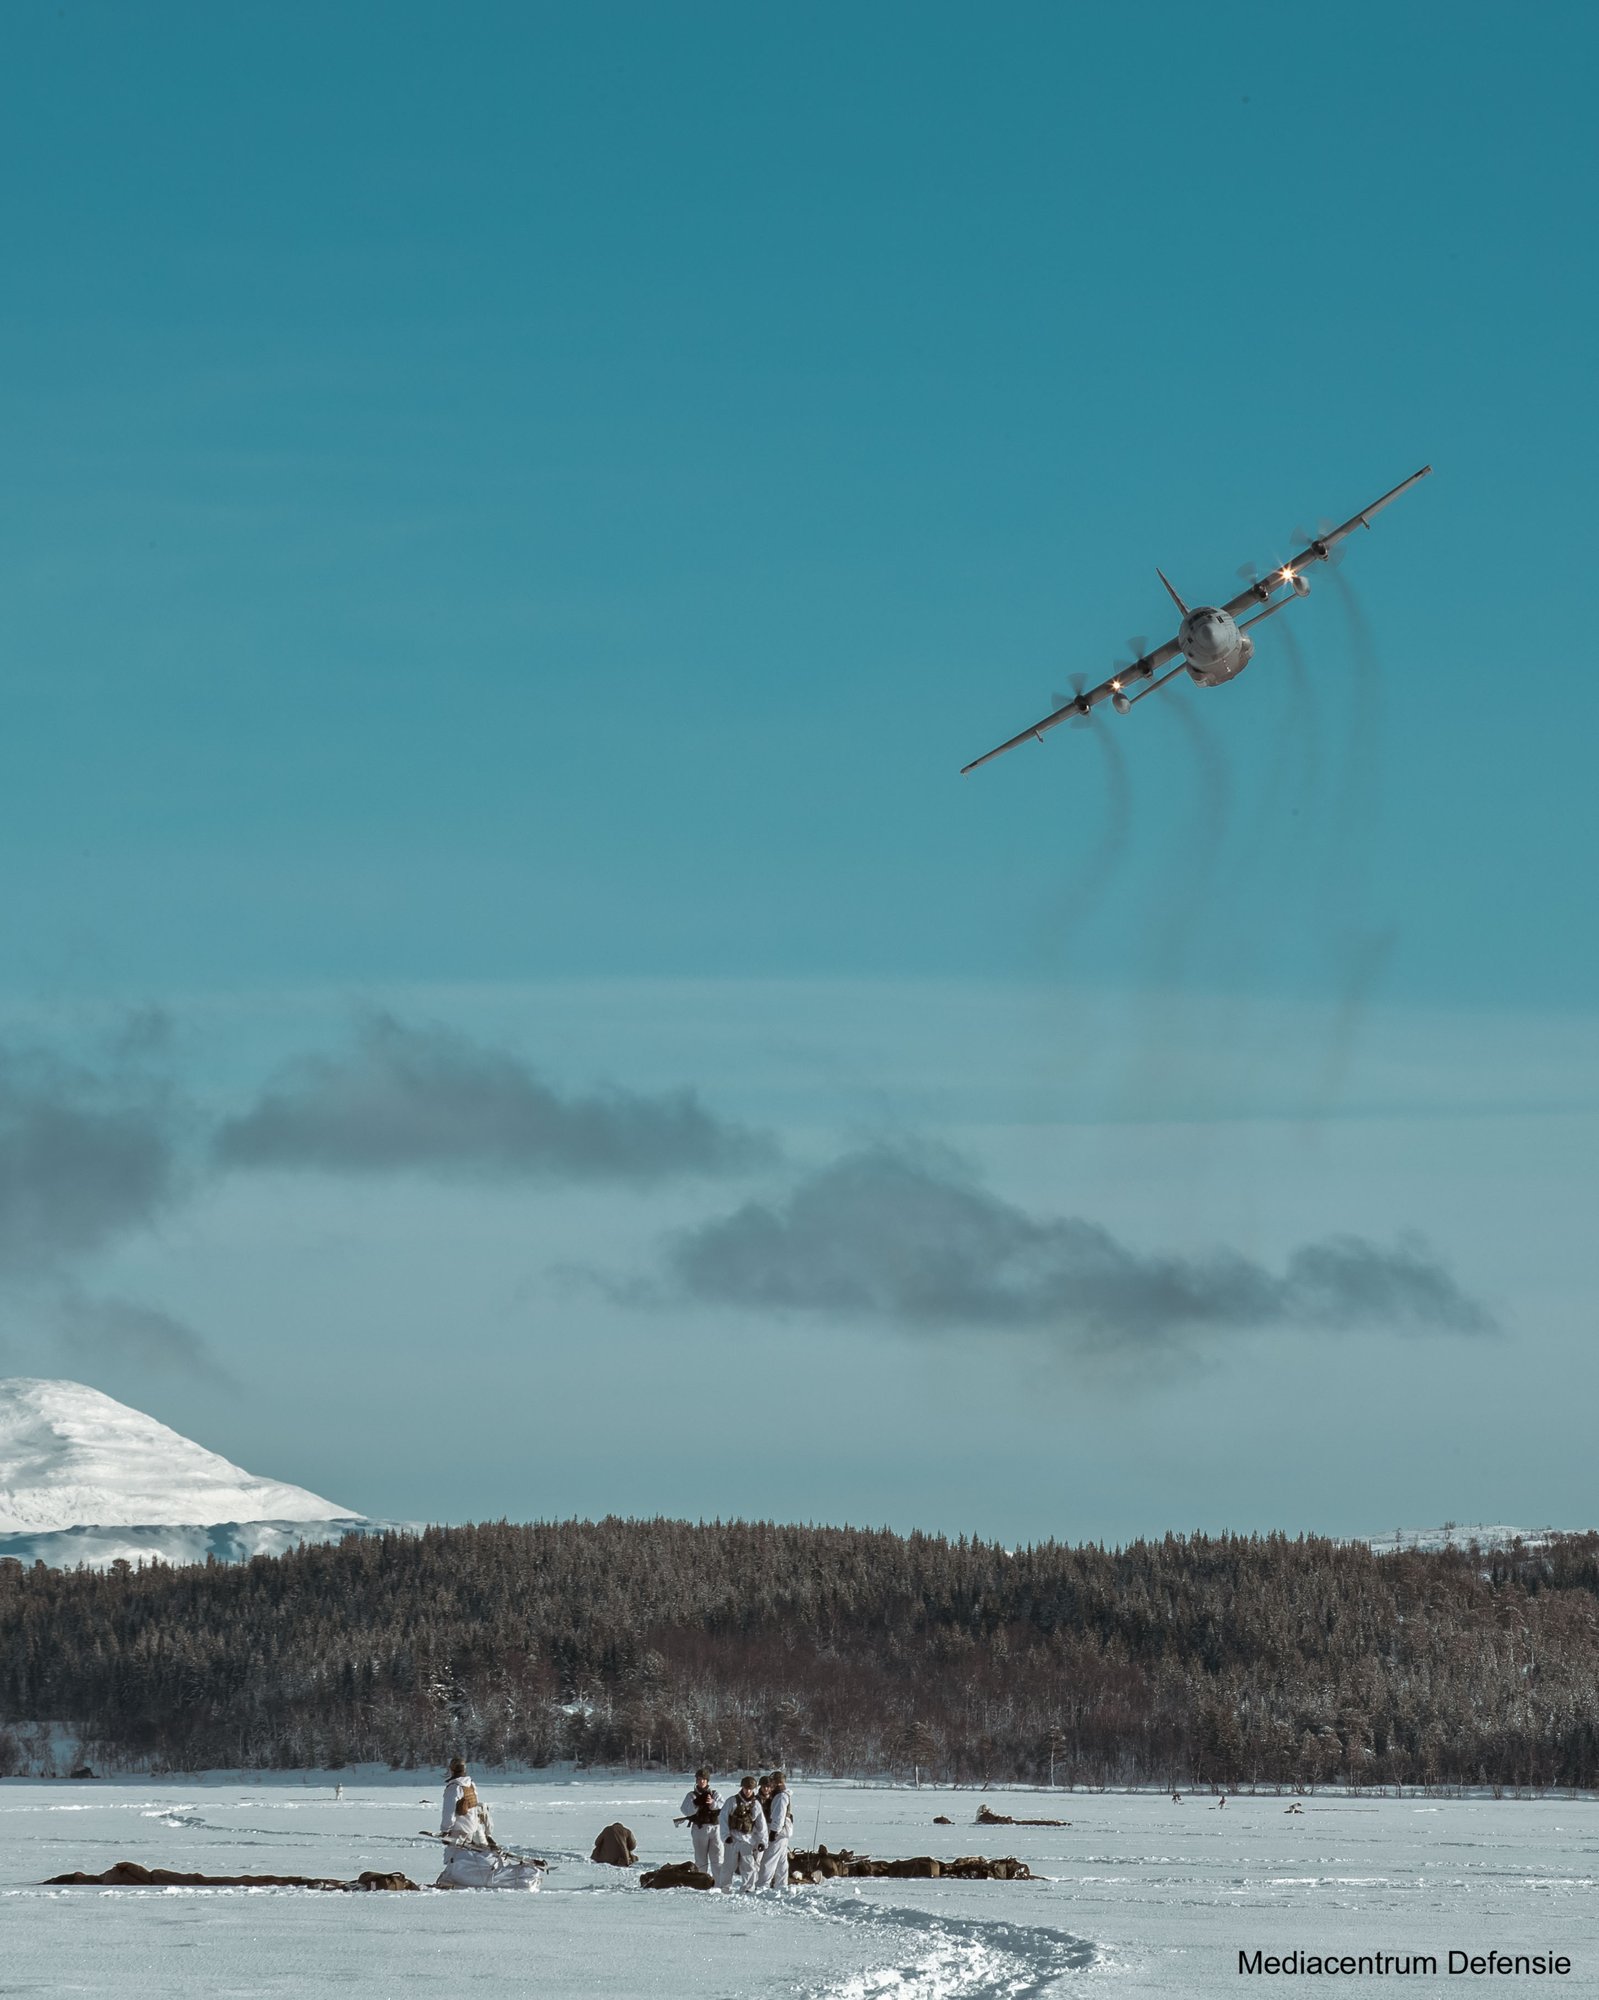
[0,1048,178,1272]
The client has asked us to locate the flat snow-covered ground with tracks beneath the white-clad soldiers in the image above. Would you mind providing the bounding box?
[0,1774,1599,2000]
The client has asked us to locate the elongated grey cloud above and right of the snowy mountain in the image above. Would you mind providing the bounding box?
[214,1014,776,1182]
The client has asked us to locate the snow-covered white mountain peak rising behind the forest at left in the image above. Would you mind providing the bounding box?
[0,1376,360,1534]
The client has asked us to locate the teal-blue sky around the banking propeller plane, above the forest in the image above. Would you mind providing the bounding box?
[0,4,1599,1538]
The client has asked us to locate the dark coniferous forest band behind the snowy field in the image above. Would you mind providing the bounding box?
[0,1520,1599,1788]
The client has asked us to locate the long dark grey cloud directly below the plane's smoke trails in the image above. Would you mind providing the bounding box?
[668,1148,1493,1350]
